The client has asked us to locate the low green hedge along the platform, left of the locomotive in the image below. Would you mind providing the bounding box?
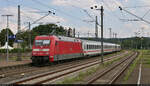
[0,48,32,53]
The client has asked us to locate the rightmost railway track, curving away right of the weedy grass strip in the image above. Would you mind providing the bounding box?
[86,52,138,84]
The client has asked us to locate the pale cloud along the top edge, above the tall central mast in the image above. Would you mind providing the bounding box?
[52,0,127,11]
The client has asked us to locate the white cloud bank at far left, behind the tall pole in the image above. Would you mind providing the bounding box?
[0,7,67,33]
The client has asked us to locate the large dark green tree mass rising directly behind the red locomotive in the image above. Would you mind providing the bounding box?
[17,24,66,48]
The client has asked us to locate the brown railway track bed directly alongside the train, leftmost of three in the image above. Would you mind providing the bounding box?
[0,51,127,83]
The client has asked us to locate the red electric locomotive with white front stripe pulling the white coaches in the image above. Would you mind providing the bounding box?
[31,36,83,63]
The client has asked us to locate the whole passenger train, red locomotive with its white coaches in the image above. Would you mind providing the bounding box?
[31,35,121,64]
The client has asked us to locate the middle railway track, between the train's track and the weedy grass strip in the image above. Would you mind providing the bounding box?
[9,50,130,84]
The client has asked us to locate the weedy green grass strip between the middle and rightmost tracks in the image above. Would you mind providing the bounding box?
[56,52,131,84]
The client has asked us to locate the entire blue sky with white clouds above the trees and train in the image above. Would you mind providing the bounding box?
[0,0,150,38]
